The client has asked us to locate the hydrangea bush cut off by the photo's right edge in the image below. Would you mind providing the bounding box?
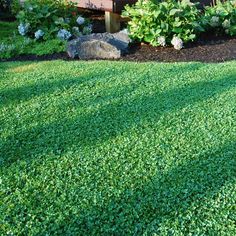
[203,0,236,36]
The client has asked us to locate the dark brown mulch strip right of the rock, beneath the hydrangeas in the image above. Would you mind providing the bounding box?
[122,37,236,62]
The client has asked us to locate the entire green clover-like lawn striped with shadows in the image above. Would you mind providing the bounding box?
[0,61,236,235]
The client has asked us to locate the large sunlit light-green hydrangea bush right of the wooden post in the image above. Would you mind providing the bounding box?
[123,0,203,49]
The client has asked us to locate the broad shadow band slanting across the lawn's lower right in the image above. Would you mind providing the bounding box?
[45,142,236,235]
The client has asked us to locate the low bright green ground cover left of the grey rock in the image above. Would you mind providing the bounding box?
[0,21,65,59]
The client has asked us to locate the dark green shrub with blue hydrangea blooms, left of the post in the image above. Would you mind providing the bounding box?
[17,0,91,40]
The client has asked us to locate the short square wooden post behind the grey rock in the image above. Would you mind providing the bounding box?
[105,11,120,33]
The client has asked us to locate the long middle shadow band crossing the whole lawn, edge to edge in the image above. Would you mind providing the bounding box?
[0,69,236,166]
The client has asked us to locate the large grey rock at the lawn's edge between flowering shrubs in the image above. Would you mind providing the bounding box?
[67,31,130,59]
